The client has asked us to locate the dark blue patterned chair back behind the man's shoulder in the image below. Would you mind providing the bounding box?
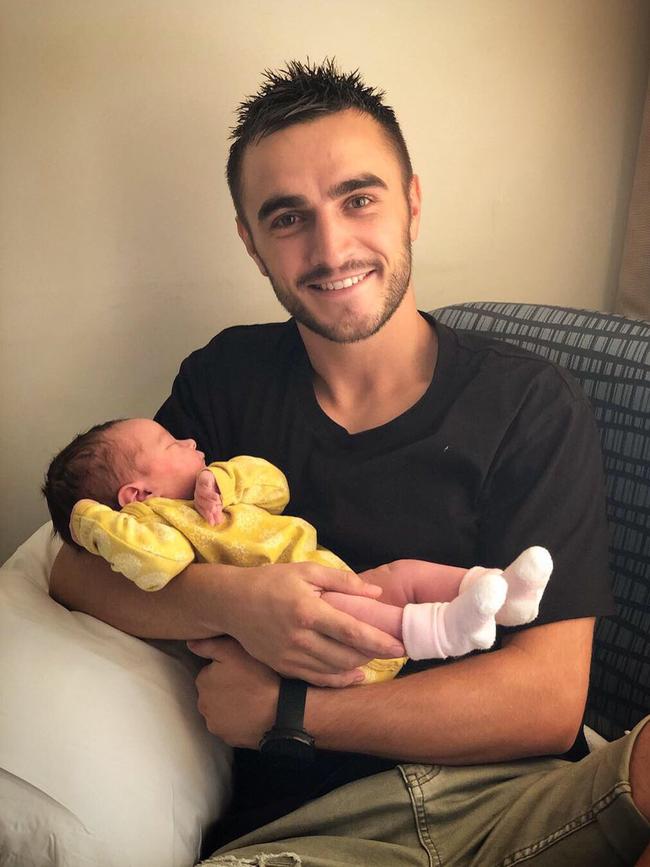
[433,302,650,739]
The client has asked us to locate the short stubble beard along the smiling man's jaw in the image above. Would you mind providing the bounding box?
[267,232,412,343]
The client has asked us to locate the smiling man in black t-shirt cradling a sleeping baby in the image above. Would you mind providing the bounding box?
[52,57,650,867]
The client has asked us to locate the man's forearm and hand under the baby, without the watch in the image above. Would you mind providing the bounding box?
[50,545,402,686]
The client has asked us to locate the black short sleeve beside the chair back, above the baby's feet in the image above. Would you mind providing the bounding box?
[480,367,614,625]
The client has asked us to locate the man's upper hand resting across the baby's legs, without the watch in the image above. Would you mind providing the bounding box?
[222,563,404,686]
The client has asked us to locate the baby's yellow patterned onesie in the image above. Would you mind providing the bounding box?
[70,455,405,683]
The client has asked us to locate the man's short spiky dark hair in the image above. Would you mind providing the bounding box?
[226,59,413,222]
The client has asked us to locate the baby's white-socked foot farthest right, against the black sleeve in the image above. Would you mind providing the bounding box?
[494,546,553,626]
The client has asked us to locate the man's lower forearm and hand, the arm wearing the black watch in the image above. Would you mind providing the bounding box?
[189,618,594,764]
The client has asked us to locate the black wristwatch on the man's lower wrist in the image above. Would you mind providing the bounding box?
[259,677,314,767]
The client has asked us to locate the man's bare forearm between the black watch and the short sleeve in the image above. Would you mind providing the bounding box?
[306,618,594,764]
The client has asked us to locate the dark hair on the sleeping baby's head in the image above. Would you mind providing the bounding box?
[41,418,135,550]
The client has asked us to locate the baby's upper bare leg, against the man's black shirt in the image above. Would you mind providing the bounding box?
[361,560,467,607]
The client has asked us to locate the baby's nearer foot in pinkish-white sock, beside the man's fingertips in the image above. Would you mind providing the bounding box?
[402,569,508,659]
